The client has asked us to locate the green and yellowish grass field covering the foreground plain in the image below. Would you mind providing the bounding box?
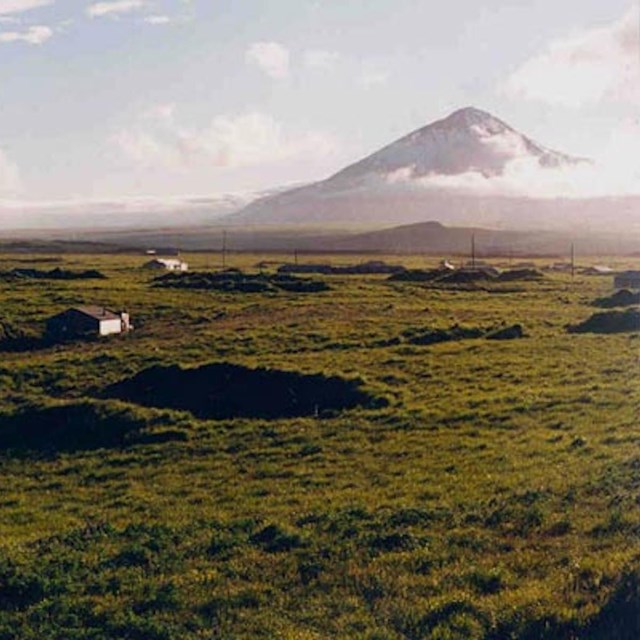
[0,255,640,640]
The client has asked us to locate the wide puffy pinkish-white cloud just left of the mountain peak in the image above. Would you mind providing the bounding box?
[113,105,337,171]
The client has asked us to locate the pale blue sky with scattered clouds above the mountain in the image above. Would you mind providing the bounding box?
[0,0,640,204]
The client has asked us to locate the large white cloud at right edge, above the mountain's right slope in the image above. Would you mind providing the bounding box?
[503,6,640,107]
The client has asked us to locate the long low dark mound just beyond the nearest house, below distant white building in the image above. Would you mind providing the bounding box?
[153,269,330,293]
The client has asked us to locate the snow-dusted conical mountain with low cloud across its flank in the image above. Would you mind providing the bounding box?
[229,108,640,229]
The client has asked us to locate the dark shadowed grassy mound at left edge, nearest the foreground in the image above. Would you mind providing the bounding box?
[0,402,185,452]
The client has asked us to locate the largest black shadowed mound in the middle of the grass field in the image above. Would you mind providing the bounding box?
[104,363,386,419]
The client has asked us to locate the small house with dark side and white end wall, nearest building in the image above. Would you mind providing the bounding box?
[47,305,132,338]
